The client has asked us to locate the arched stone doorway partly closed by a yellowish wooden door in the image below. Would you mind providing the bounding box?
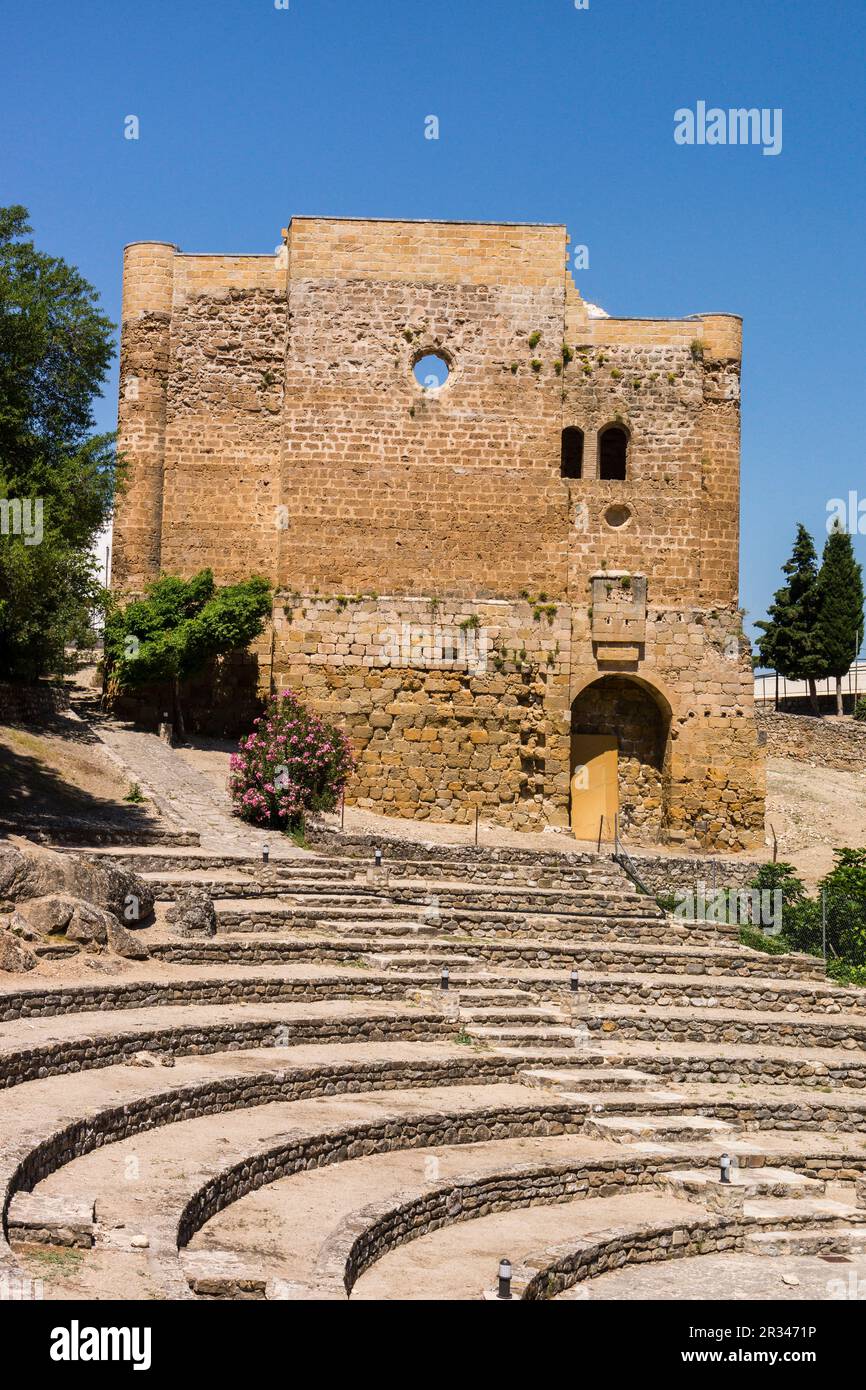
[570,676,671,841]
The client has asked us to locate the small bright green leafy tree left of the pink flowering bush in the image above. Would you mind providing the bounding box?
[106,570,271,738]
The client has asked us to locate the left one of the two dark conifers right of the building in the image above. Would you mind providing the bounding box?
[755,524,826,714]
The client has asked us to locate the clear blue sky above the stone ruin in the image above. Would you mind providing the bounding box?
[0,0,866,639]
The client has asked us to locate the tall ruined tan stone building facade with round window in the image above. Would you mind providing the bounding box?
[113,217,763,849]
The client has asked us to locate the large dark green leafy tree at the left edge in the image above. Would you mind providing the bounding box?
[0,206,117,680]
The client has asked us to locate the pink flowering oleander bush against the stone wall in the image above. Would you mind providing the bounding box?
[228,691,354,830]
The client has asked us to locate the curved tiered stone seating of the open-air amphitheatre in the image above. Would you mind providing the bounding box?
[0,845,866,1300]
